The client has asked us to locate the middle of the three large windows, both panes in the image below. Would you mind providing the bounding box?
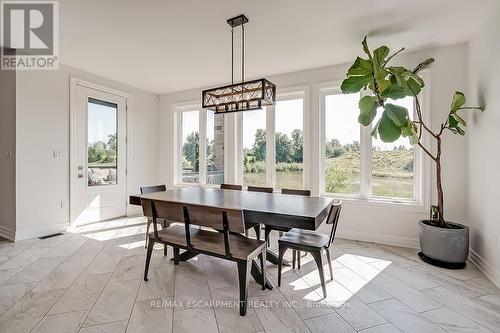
[241,94,304,189]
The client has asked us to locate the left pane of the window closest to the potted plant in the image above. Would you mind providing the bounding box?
[324,94,361,194]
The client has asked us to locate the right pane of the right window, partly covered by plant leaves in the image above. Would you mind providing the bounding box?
[372,97,414,199]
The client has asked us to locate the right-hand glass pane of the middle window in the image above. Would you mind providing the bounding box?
[275,99,304,189]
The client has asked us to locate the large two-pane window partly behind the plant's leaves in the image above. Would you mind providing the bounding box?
[320,89,420,201]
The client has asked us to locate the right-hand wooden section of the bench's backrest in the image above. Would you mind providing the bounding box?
[184,205,245,233]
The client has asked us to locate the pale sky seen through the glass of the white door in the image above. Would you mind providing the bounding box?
[87,102,117,143]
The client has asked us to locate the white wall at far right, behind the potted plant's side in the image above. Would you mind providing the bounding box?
[468,4,500,287]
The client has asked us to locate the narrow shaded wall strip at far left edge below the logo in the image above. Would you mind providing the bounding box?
[0,52,16,239]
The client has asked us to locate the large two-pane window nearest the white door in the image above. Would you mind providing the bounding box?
[177,108,224,185]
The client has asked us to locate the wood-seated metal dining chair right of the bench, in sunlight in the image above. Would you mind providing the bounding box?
[278,199,342,297]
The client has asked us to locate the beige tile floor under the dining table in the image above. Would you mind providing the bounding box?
[0,217,500,333]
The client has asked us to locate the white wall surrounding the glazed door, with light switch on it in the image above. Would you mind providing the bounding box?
[16,64,157,239]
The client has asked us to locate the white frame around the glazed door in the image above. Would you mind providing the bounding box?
[69,76,132,227]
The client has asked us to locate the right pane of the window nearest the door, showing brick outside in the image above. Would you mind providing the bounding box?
[206,111,224,184]
